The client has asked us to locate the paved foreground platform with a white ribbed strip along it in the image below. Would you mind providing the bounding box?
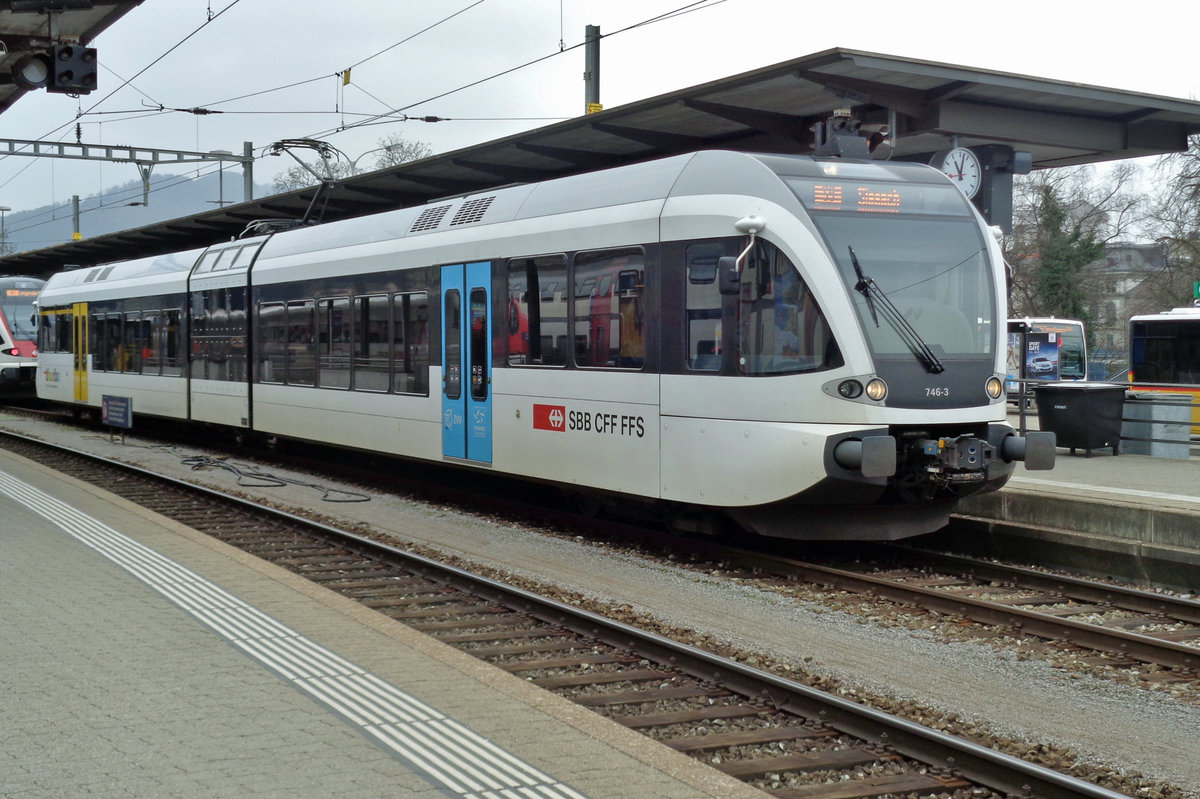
[0,451,766,799]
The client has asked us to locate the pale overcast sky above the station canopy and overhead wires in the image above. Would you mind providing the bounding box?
[0,0,1200,224]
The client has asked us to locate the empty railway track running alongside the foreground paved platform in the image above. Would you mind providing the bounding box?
[0,434,1121,799]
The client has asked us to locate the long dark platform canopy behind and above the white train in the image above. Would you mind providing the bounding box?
[7,48,1200,275]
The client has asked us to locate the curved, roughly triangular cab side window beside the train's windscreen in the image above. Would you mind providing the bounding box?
[738,239,842,374]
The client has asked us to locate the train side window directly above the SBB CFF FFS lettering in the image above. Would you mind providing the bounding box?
[574,247,646,368]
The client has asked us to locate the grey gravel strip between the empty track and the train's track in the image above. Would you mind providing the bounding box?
[0,414,1200,799]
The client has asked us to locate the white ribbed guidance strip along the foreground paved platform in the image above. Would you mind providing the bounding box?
[0,471,586,799]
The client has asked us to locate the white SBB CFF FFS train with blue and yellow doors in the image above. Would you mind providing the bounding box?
[37,151,1054,539]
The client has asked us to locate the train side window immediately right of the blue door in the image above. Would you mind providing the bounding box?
[504,254,569,366]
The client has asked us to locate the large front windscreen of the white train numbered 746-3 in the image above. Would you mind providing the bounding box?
[787,178,997,359]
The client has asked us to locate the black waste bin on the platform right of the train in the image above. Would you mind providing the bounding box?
[1034,383,1126,457]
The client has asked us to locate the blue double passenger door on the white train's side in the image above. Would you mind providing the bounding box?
[442,262,492,463]
